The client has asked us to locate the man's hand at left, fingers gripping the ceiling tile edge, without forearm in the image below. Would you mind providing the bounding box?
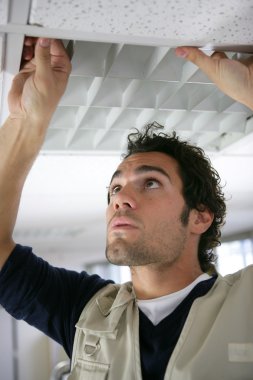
[8,37,71,127]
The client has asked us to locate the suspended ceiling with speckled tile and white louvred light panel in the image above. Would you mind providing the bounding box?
[1,0,253,153]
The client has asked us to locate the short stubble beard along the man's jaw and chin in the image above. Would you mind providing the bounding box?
[106,206,189,267]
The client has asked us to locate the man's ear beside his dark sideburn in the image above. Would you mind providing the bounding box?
[190,205,214,235]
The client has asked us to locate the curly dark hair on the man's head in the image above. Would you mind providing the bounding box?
[124,122,226,272]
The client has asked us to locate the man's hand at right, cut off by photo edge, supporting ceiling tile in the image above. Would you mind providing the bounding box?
[176,47,253,110]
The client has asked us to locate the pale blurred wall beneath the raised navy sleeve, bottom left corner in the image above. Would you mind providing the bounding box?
[0,309,67,380]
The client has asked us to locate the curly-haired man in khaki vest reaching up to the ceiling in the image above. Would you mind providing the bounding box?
[0,39,253,380]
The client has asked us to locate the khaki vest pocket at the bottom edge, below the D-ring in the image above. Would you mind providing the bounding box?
[68,359,109,380]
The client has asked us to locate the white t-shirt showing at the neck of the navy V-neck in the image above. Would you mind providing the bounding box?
[137,273,211,326]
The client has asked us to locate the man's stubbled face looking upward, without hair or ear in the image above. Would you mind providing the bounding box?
[106,152,194,266]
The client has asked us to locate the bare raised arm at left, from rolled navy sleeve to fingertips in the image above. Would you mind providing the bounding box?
[0,38,71,268]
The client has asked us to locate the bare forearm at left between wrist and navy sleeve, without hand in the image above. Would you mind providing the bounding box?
[0,118,47,268]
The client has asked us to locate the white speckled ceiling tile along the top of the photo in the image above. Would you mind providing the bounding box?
[29,0,253,45]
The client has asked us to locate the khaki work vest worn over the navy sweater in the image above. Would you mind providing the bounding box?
[69,266,253,380]
